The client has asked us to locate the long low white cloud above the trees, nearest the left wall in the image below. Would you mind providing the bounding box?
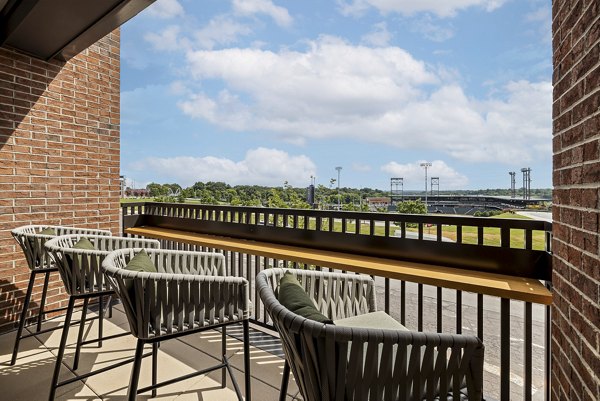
[131,148,316,186]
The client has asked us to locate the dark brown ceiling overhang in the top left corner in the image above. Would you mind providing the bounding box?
[0,0,155,61]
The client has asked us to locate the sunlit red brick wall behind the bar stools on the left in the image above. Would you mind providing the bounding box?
[0,30,120,332]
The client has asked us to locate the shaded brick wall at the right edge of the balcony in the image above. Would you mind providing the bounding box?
[552,0,600,400]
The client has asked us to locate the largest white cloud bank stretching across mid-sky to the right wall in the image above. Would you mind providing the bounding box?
[179,37,552,163]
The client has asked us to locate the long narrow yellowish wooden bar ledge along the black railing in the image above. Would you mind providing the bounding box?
[125,226,552,305]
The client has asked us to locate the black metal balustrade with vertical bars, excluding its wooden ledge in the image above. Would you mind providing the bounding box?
[122,202,552,401]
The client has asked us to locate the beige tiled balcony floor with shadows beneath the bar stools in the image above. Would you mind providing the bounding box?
[0,306,298,401]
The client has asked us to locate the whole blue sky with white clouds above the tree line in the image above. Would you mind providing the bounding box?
[121,0,552,191]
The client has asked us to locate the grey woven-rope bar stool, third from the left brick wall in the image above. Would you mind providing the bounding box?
[102,249,251,401]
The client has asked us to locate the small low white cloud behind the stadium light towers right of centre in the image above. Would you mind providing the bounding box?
[381,160,469,189]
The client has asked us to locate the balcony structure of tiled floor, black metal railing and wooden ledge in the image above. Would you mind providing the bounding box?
[0,202,551,400]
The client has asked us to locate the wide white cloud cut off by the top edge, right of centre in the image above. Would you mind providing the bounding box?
[338,0,506,18]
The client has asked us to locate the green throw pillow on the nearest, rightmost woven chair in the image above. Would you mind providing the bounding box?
[277,272,333,324]
